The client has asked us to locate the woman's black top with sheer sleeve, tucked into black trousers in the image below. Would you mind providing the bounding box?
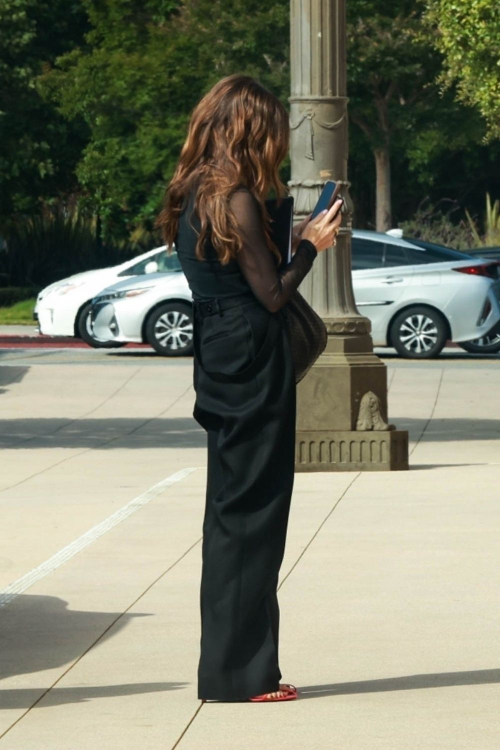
[175,188,317,312]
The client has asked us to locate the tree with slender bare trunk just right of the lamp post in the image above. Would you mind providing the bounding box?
[347,0,484,231]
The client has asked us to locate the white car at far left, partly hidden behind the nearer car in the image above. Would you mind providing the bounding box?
[33,247,179,346]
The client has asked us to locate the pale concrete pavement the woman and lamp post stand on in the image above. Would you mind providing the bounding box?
[0,360,500,750]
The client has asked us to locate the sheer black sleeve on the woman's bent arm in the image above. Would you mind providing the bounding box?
[229,189,318,312]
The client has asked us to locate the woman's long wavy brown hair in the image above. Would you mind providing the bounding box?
[157,75,290,264]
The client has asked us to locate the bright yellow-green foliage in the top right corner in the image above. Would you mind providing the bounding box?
[425,0,500,139]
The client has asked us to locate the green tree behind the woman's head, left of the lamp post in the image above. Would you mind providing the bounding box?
[42,0,288,241]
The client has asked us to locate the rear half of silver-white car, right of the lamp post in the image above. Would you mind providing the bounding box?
[352,231,500,358]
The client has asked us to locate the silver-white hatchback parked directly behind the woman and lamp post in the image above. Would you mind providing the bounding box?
[92,230,500,358]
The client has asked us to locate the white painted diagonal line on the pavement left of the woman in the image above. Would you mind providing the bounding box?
[0,467,197,609]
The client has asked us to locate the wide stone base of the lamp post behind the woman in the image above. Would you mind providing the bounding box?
[295,334,408,471]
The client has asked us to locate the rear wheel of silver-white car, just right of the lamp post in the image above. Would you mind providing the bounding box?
[390,305,448,359]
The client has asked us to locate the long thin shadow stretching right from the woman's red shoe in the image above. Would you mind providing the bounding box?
[299,669,500,700]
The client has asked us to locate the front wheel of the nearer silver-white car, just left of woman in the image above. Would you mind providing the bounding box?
[145,302,193,357]
